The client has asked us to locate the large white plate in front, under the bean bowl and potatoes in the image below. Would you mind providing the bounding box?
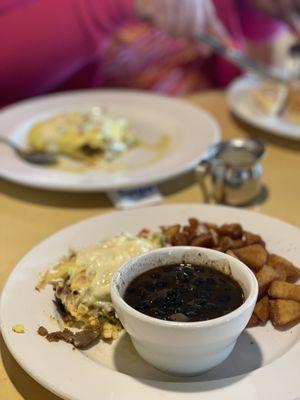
[0,204,300,400]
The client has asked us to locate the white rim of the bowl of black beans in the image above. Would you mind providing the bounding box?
[110,246,258,329]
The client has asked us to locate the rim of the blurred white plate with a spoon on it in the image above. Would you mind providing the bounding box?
[0,89,221,192]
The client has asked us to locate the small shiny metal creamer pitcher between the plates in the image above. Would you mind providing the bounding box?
[196,138,265,206]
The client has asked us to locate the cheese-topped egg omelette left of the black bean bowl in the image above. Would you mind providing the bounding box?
[37,233,162,336]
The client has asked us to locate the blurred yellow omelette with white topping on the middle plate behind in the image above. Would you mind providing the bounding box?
[28,107,138,164]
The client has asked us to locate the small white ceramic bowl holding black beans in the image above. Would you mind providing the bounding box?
[111,247,258,376]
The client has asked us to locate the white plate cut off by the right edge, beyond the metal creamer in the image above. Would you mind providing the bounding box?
[227,76,300,140]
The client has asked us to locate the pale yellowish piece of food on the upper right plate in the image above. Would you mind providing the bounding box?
[252,82,288,116]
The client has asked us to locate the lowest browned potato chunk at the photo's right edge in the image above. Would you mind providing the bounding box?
[270,299,300,326]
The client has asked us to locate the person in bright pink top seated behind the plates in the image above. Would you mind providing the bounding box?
[0,0,299,106]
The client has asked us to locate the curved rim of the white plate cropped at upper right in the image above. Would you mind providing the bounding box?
[227,75,300,140]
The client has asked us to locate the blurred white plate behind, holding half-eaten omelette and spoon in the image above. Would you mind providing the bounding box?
[0,90,220,191]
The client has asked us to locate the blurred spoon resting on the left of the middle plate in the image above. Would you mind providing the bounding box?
[0,136,58,165]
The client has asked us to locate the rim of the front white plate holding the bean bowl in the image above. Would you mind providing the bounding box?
[0,204,300,400]
